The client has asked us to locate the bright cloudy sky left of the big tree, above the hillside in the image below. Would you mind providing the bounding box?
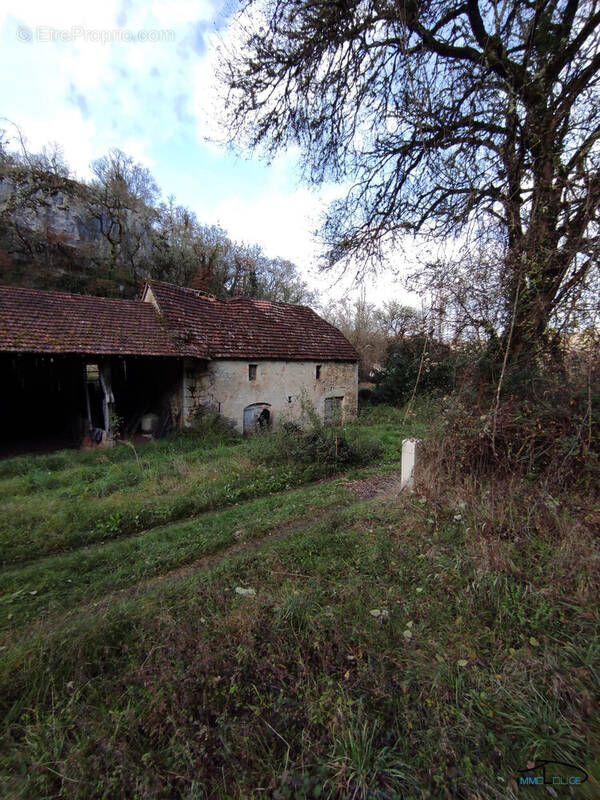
[0,0,414,304]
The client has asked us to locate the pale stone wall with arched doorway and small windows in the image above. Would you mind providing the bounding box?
[183,360,358,432]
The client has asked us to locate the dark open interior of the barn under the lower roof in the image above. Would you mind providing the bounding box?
[0,353,181,456]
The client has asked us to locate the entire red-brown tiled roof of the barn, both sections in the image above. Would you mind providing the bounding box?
[0,281,358,361]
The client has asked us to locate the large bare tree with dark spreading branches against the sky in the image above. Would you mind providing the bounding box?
[221,0,600,368]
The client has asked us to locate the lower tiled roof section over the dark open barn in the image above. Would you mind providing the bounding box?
[0,286,179,356]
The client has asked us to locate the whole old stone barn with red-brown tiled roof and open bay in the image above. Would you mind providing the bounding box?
[0,281,358,446]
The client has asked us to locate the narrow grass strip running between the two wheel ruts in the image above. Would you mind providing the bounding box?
[0,481,351,630]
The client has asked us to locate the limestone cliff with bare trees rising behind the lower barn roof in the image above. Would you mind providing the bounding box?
[0,170,155,297]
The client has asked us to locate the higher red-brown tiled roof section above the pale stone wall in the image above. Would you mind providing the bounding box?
[148,281,358,361]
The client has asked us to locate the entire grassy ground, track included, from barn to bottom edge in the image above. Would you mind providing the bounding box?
[0,408,600,800]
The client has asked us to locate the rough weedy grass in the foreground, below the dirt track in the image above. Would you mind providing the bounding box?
[0,490,600,798]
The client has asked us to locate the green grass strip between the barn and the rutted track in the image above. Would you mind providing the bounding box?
[0,410,408,566]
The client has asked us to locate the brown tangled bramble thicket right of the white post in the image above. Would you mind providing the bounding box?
[428,364,600,487]
